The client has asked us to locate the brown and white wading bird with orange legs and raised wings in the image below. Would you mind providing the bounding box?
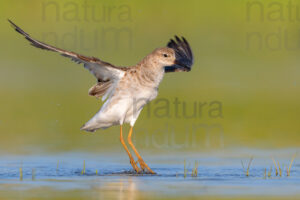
[8,19,194,174]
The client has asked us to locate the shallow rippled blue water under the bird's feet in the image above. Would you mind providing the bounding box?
[0,150,300,199]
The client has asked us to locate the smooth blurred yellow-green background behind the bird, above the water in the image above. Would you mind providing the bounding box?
[0,0,300,154]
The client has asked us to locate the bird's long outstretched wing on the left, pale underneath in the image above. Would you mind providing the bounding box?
[8,20,127,82]
